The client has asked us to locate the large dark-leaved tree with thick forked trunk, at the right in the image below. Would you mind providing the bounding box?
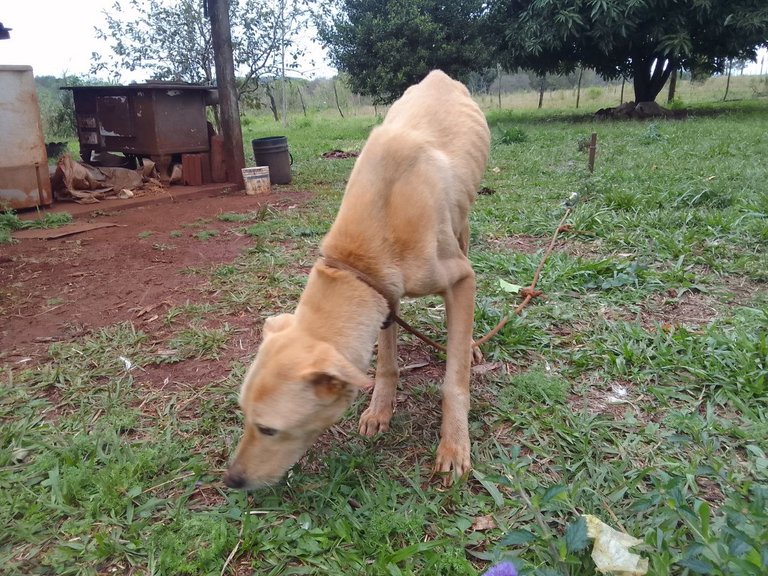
[489,0,768,102]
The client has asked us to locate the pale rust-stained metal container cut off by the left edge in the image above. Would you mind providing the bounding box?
[0,66,53,209]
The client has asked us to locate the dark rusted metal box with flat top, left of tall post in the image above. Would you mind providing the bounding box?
[64,82,215,161]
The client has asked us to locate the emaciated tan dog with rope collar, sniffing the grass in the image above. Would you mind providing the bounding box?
[224,71,490,488]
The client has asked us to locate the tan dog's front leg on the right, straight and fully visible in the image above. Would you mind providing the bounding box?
[435,260,475,485]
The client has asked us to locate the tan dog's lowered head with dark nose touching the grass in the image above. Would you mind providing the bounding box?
[224,314,372,489]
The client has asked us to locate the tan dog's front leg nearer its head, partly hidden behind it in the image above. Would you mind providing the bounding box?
[360,310,400,436]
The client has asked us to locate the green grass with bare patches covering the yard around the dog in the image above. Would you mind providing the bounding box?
[0,95,768,576]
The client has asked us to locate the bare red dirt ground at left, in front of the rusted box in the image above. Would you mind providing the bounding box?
[0,191,309,364]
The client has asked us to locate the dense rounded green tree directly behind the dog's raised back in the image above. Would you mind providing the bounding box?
[318,0,490,104]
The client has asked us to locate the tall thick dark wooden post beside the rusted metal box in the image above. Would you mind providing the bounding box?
[207,0,245,189]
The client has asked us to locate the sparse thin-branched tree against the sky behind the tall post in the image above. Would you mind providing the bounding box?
[91,0,312,96]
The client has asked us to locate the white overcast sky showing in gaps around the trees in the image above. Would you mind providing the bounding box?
[0,0,768,82]
